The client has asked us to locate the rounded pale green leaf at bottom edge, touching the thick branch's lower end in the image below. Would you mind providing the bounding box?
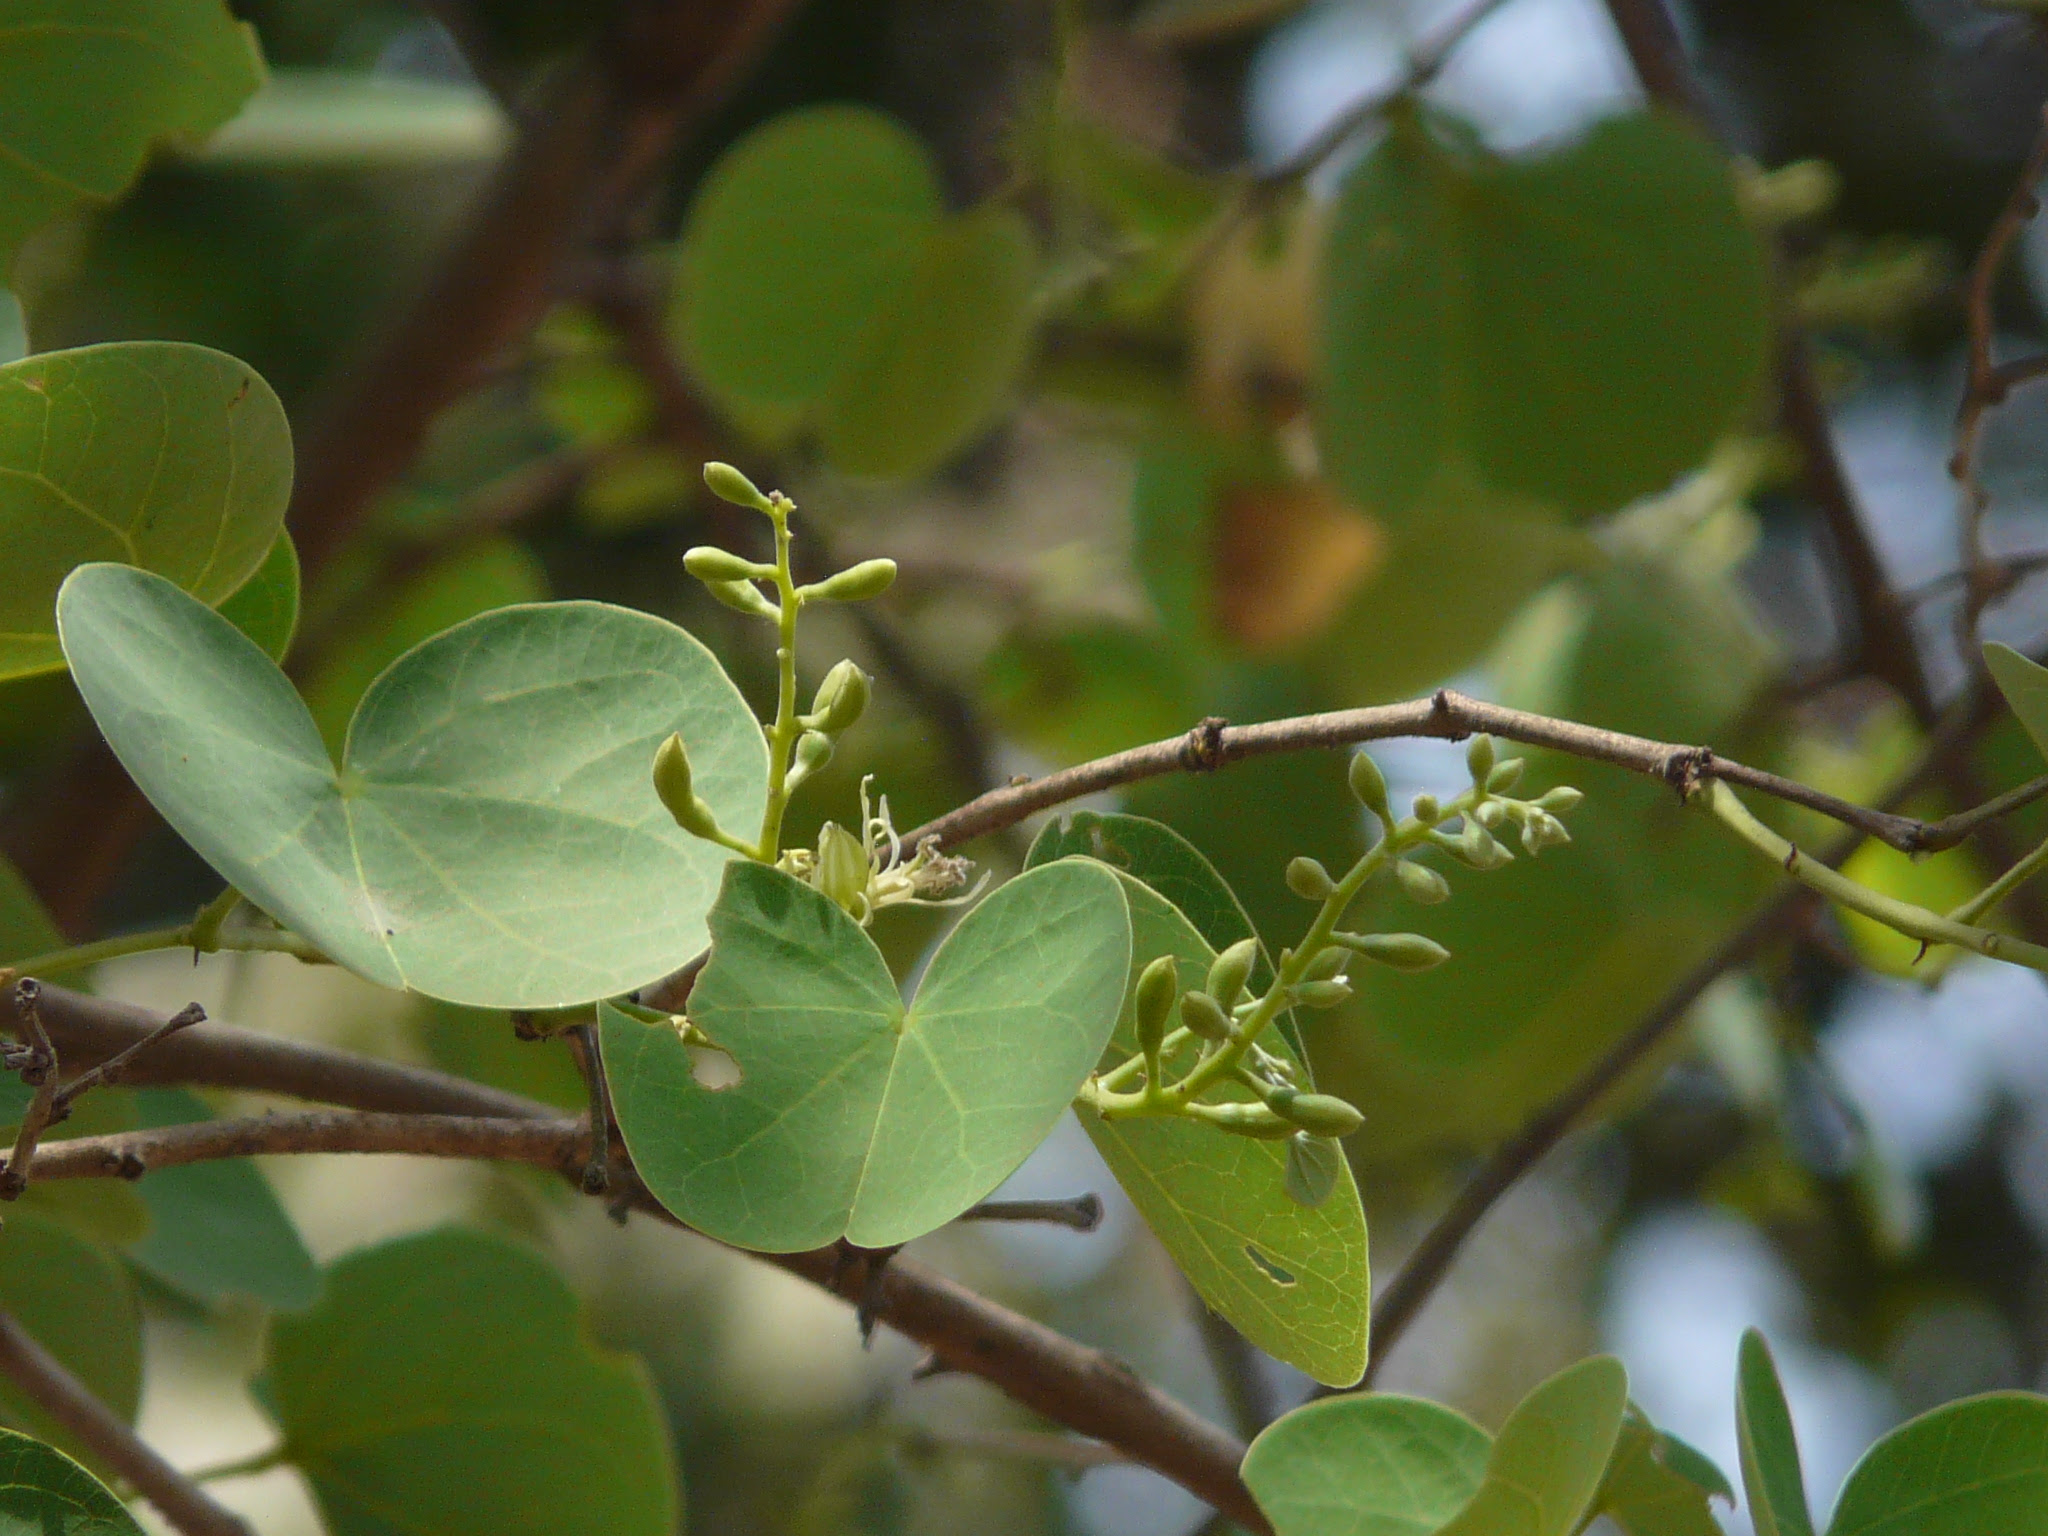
[1243,1393,1493,1536]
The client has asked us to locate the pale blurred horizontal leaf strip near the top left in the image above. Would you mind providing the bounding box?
[188,70,512,170]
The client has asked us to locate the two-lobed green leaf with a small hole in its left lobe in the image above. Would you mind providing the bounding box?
[600,860,1130,1253]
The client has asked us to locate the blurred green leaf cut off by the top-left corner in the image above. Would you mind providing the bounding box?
[0,0,262,268]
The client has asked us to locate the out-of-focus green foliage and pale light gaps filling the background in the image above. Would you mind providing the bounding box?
[19,0,2048,1536]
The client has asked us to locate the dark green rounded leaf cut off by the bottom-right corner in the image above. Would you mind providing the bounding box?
[1827,1393,2048,1536]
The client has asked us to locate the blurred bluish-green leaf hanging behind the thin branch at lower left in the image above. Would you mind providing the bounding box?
[129,1087,319,1311]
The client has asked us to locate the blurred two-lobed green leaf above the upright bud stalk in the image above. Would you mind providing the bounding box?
[676,106,1038,477]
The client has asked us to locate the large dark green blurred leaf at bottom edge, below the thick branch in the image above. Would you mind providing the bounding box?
[268,1231,680,1536]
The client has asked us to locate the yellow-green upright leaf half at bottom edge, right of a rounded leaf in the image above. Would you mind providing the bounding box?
[1440,1356,1628,1536]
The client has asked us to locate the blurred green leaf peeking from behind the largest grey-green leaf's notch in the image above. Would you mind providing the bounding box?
[305,537,547,758]
